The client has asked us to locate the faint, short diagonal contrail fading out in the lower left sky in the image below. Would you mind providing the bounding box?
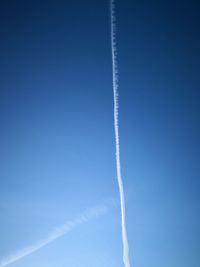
[0,200,113,267]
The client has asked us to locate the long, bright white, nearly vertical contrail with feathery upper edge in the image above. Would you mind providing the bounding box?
[110,0,130,267]
